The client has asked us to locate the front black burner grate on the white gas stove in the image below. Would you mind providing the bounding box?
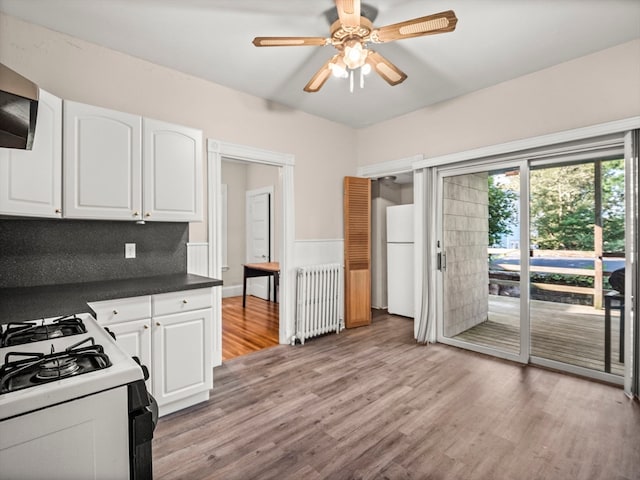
[0,337,111,394]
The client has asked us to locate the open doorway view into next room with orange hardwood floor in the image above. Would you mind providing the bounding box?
[221,157,282,361]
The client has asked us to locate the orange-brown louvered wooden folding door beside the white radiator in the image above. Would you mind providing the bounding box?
[344,177,371,328]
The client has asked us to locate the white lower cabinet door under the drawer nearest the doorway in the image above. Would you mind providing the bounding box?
[153,308,213,406]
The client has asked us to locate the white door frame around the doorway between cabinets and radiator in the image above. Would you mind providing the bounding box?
[207,138,295,356]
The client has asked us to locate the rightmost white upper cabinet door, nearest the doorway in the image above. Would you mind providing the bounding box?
[143,118,203,222]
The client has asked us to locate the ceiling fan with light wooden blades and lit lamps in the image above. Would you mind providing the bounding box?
[253,0,458,92]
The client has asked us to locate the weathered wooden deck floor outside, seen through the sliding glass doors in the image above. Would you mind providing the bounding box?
[455,295,624,376]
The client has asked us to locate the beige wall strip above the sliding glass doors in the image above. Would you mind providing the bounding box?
[358,40,640,165]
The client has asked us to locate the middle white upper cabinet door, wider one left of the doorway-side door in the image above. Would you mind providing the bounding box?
[63,101,142,220]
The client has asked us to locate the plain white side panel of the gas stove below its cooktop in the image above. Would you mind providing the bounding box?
[0,386,129,480]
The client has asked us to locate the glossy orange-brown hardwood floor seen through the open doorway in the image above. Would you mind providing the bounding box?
[222,295,280,361]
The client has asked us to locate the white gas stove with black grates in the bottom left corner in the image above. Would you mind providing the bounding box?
[0,314,153,479]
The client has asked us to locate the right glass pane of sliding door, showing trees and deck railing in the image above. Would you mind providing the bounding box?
[529,157,626,377]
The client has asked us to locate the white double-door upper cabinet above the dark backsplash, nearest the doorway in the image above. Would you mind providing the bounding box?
[64,101,203,222]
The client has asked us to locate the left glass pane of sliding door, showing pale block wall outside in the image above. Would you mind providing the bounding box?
[438,164,528,361]
